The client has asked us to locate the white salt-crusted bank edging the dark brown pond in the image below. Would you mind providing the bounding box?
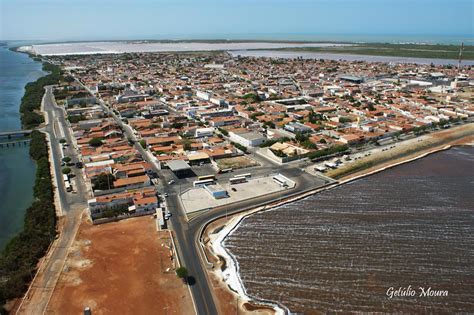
[206,136,474,314]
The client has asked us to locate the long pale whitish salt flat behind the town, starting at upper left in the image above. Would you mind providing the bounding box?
[21,41,345,56]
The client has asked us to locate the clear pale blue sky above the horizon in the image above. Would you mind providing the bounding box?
[0,0,474,41]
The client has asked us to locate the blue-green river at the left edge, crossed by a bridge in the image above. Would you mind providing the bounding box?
[0,47,43,248]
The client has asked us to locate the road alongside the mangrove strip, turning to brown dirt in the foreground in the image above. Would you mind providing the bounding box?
[17,87,87,314]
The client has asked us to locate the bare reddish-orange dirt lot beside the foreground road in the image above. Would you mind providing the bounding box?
[47,216,195,315]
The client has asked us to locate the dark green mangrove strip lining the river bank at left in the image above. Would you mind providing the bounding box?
[0,50,59,311]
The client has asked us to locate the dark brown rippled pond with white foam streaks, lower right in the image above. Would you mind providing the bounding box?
[225,148,474,314]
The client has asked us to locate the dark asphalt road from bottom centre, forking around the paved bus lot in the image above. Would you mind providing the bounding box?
[77,77,334,315]
